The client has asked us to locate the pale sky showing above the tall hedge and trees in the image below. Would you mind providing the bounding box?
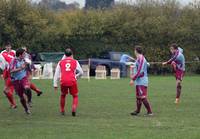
[32,0,193,7]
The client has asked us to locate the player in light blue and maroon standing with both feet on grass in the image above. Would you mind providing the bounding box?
[130,46,153,116]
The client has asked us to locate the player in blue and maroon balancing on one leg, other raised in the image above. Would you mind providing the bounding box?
[162,43,185,104]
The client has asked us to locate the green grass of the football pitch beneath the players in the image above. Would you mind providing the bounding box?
[0,76,200,139]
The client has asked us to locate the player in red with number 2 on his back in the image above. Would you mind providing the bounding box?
[53,48,83,116]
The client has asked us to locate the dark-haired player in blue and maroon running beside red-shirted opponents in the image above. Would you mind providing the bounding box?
[10,48,32,114]
